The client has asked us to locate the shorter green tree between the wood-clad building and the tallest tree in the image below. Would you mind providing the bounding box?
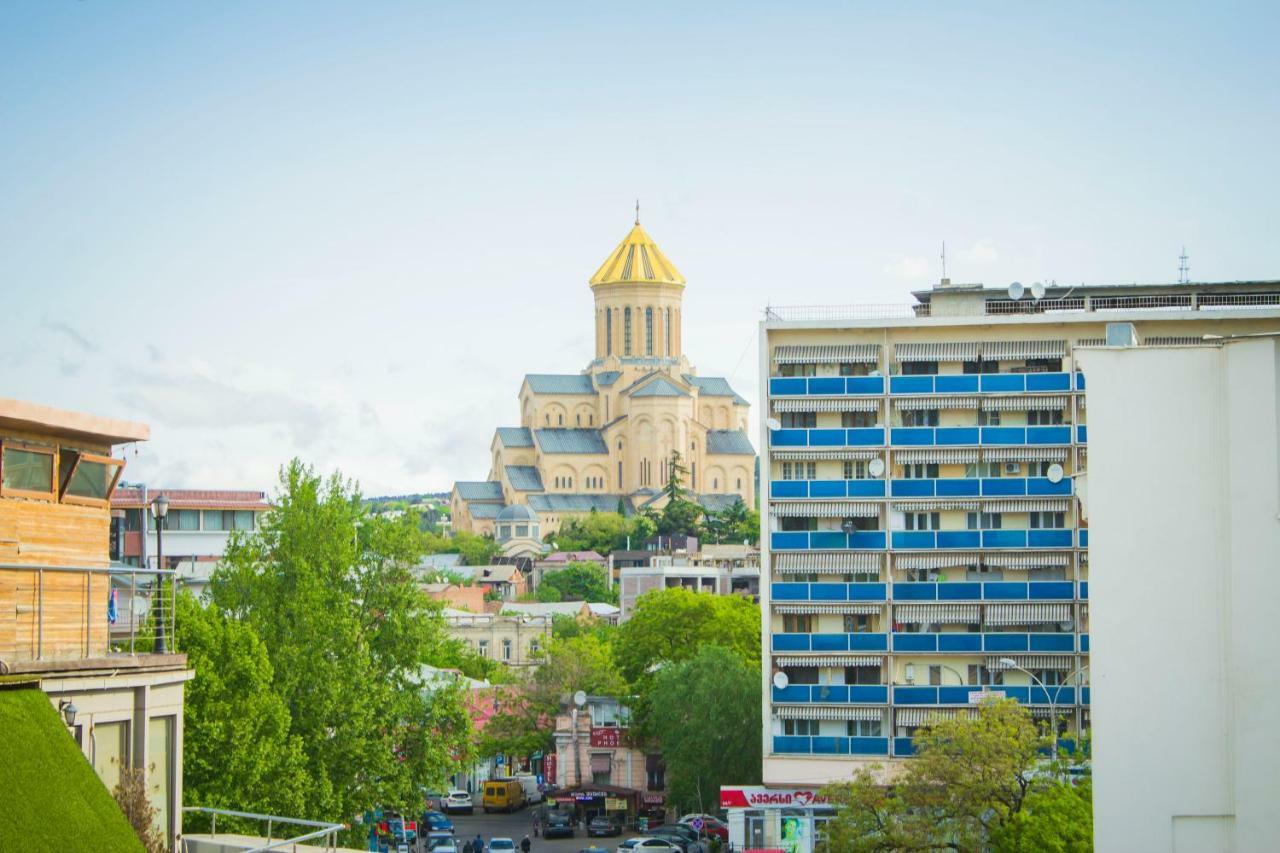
[177,590,308,824]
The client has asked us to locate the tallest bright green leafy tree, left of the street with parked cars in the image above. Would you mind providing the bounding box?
[202,460,470,820]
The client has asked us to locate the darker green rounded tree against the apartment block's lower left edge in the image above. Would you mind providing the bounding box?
[648,646,760,812]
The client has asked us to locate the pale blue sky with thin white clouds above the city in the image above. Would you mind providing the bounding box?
[0,0,1280,494]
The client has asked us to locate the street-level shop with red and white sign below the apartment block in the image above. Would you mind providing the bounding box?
[721,785,835,853]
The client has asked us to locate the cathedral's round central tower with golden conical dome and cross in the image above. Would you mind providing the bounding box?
[591,211,685,361]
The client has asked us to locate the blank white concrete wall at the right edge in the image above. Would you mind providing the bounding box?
[1076,338,1280,852]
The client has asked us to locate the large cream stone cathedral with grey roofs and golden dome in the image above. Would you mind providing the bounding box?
[452,216,755,551]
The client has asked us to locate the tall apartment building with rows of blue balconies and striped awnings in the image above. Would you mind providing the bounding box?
[726,279,1280,850]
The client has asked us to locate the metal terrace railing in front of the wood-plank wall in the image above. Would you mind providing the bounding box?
[0,564,175,671]
